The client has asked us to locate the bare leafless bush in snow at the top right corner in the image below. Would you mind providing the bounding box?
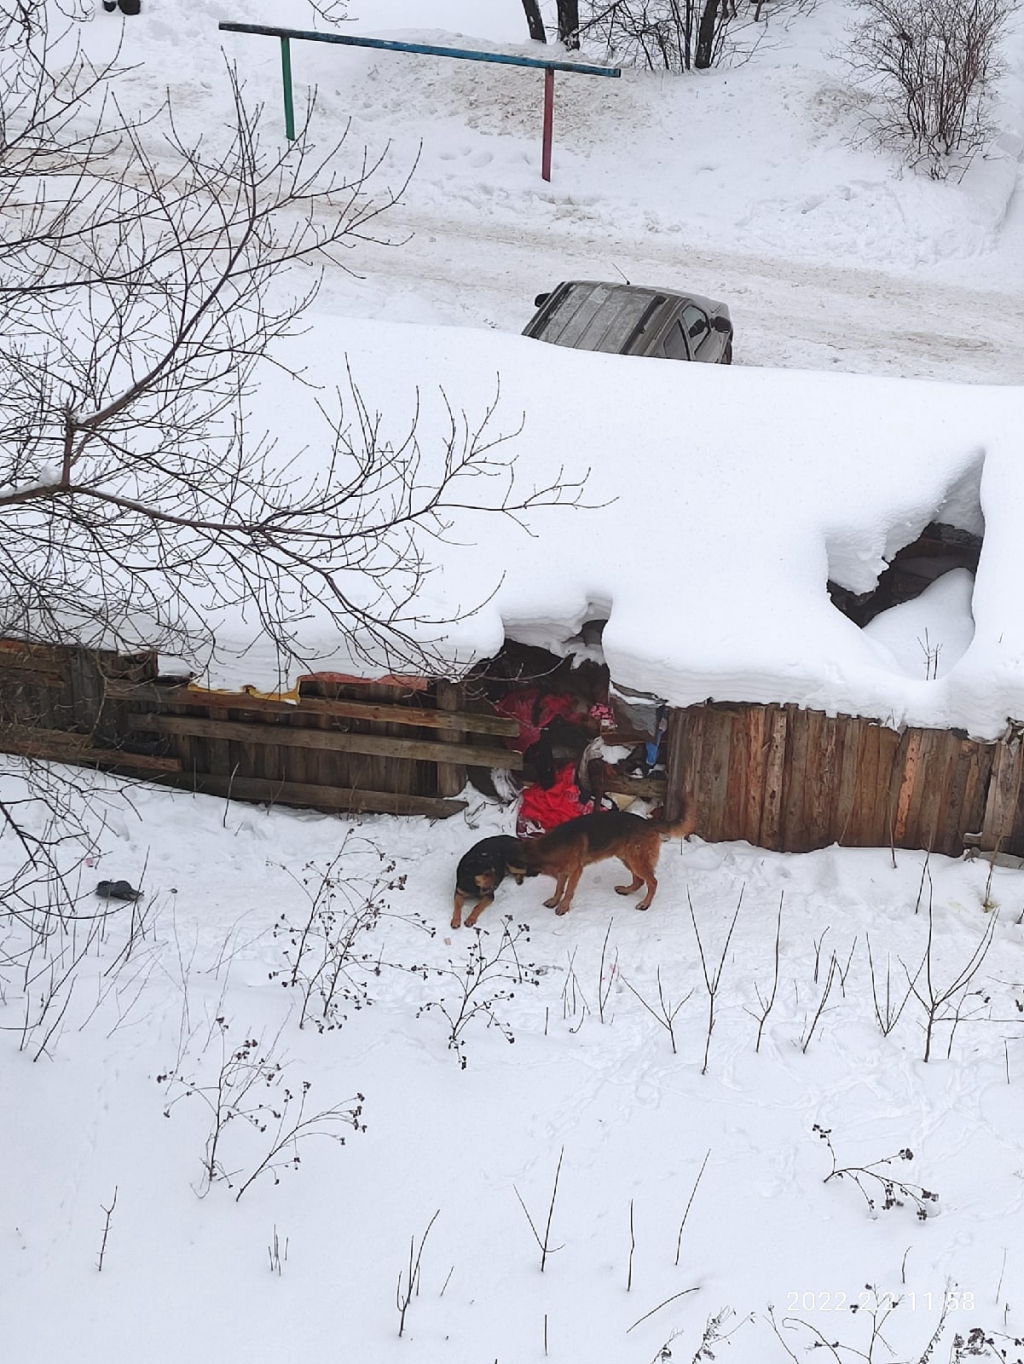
[848,0,1019,180]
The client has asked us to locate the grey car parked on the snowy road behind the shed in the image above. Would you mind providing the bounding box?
[522,280,732,364]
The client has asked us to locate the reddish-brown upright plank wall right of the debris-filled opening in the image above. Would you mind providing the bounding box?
[668,702,1024,857]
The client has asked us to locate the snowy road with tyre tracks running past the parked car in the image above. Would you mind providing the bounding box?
[319,206,1024,383]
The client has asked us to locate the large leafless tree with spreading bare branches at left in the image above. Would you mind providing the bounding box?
[0,0,575,916]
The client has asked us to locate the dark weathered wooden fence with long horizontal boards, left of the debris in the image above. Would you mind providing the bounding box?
[0,641,522,817]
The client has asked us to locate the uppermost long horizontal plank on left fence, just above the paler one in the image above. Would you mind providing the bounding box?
[106,681,519,737]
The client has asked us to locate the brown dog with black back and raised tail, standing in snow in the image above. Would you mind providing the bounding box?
[522,801,695,914]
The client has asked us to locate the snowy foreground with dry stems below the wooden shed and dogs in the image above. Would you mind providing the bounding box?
[0,783,1024,1364]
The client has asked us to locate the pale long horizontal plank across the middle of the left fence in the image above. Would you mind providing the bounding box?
[127,713,522,768]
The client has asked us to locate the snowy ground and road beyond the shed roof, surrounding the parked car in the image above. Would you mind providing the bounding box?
[90,0,1024,383]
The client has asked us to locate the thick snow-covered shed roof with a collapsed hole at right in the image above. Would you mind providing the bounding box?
[175,316,1024,738]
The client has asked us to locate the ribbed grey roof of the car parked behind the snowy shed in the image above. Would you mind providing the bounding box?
[526,280,725,355]
